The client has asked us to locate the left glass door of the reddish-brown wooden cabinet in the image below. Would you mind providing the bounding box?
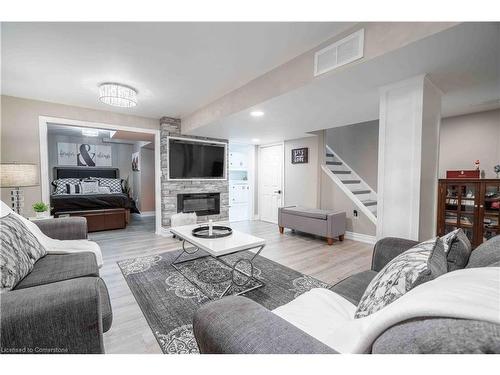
[444,182,478,242]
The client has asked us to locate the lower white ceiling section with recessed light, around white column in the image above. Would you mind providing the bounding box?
[196,23,500,144]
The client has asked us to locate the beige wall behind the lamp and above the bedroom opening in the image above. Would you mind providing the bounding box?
[0,96,159,215]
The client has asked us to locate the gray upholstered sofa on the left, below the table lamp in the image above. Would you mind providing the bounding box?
[0,218,113,353]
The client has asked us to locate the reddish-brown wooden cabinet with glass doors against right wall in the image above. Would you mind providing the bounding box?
[437,179,500,248]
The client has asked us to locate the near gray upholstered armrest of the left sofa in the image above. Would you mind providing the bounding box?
[1,277,109,354]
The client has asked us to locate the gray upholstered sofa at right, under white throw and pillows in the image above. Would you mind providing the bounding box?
[193,236,500,354]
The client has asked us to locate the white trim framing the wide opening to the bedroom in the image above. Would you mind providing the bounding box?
[38,116,166,235]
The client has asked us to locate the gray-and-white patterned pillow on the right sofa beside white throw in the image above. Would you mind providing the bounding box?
[354,237,447,318]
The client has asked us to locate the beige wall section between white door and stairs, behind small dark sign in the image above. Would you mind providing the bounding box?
[284,136,320,208]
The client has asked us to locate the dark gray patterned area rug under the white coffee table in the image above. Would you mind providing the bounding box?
[118,251,329,354]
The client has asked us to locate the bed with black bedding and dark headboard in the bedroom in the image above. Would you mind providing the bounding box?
[50,167,138,232]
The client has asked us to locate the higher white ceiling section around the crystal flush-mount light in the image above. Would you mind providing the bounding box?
[2,22,352,118]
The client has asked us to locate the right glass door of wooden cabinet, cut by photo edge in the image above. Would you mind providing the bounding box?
[480,181,500,242]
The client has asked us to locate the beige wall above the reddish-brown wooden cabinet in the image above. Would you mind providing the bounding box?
[439,109,500,178]
